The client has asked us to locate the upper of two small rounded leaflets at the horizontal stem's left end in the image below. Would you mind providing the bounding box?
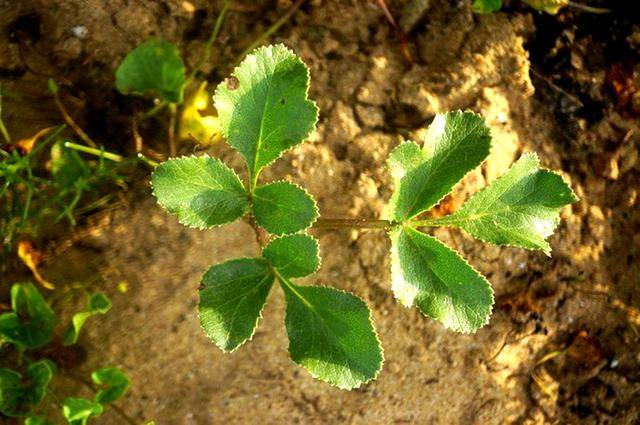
[253,181,318,235]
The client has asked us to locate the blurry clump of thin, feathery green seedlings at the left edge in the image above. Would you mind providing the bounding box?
[0,126,122,257]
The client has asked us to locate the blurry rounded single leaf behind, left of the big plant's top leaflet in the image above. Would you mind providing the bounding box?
[116,39,185,103]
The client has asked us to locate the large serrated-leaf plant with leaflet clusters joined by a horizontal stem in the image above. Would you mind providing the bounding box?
[152,45,576,389]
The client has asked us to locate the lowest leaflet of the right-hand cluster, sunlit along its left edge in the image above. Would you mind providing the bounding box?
[390,226,493,332]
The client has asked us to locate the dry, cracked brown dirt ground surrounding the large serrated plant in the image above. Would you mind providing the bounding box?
[0,0,640,424]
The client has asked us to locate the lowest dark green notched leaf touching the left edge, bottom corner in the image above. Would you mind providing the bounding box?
[0,359,56,417]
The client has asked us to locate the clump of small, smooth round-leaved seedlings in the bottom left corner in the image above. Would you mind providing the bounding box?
[0,283,130,425]
